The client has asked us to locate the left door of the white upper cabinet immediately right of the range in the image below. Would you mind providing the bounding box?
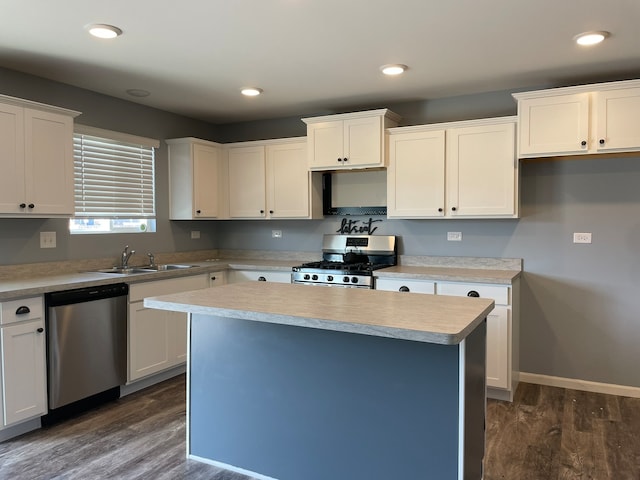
[387,130,445,218]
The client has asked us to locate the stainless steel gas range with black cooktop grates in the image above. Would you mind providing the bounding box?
[291,234,397,288]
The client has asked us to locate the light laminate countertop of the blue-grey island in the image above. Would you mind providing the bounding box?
[144,282,494,345]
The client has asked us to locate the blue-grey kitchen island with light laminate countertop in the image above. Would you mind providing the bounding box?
[144,282,493,480]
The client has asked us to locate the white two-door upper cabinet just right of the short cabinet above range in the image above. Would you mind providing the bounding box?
[387,117,519,218]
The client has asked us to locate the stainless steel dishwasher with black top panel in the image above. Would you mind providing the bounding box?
[43,283,129,423]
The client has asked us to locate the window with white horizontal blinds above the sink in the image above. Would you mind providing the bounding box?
[69,125,160,234]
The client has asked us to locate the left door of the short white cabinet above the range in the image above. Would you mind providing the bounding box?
[307,120,344,169]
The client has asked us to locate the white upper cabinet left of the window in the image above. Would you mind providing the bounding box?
[0,95,80,218]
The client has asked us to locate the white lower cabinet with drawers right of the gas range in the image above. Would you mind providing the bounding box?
[376,278,519,401]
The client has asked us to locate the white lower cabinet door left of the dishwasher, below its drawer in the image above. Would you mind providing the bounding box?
[0,319,47,426]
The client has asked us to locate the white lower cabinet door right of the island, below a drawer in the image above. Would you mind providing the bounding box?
[487,305,511,388]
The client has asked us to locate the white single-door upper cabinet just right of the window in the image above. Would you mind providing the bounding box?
[166,137,225,220]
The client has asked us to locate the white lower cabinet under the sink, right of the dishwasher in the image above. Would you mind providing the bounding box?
[127,274,211,382]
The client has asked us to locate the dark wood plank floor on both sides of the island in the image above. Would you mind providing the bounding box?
[0,376,640,480]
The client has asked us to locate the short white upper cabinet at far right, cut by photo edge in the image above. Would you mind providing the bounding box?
[513,80,640,158]
